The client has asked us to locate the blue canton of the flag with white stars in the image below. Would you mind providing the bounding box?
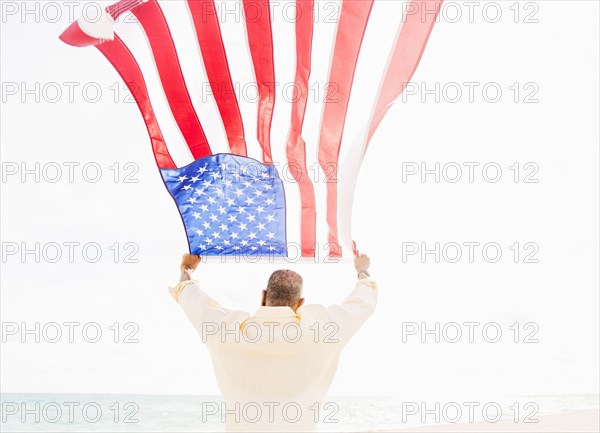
[160,153,287,256]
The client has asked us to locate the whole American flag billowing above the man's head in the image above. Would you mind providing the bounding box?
[60,0,441,258]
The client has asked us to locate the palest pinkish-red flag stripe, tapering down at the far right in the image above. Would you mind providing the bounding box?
[365,0,443,148]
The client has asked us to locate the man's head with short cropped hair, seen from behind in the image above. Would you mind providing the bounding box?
[262,269,304,312]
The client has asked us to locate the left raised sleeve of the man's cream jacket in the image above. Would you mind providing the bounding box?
[178,283,250,343]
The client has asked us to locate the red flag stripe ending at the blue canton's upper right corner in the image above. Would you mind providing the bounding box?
[243,0,275,164]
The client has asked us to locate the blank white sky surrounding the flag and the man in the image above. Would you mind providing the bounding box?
[0,1,600,396]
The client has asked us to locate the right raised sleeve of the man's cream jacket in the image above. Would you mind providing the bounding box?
[298,278,378,345]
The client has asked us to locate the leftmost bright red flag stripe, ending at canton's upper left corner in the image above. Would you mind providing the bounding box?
[96,35,177,168]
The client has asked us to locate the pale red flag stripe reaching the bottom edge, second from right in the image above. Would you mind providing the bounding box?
[318,0,373,257]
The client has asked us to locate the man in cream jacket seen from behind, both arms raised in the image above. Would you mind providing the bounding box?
[169,254,377,432]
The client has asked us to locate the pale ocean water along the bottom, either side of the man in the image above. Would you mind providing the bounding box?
[0,393,600,433]
